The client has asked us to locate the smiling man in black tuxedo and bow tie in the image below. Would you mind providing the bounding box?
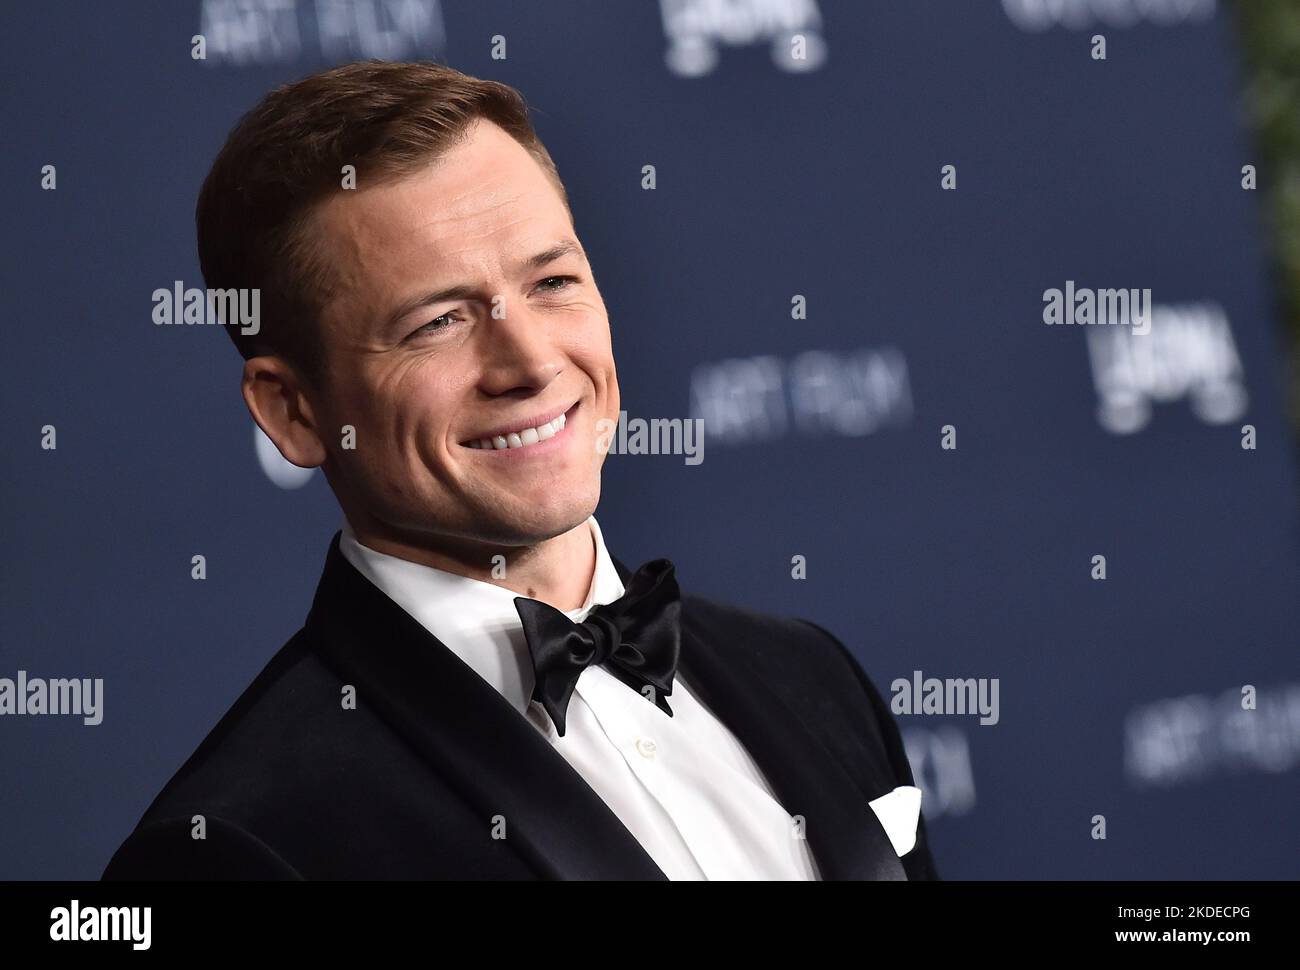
[105,62,936,879]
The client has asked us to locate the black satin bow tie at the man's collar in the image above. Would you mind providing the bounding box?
[515,559,681,737]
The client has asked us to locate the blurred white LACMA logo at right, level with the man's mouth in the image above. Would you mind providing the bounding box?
[1087,303,1248,434]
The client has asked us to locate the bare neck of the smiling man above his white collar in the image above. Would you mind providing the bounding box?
[348,519,595,610]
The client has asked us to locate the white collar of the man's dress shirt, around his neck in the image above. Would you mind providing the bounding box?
[339,515,624,714]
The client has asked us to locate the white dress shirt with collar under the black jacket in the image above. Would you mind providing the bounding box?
[341,516,819,880]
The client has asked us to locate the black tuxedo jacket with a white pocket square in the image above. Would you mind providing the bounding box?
[104,534,937,879]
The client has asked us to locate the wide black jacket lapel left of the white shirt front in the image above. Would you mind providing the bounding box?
[307,534,667,880]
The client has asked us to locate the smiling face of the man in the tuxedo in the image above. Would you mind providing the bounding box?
[304,121,619,545]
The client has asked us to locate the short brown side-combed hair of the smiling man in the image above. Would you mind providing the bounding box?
[195,61,572,382]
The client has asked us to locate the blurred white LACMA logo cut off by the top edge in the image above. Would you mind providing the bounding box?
[659,0,827,78]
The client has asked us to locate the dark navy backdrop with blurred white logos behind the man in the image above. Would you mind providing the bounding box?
[0,0,1300,879]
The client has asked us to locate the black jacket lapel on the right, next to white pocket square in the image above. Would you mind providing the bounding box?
[610,555,907,880]
